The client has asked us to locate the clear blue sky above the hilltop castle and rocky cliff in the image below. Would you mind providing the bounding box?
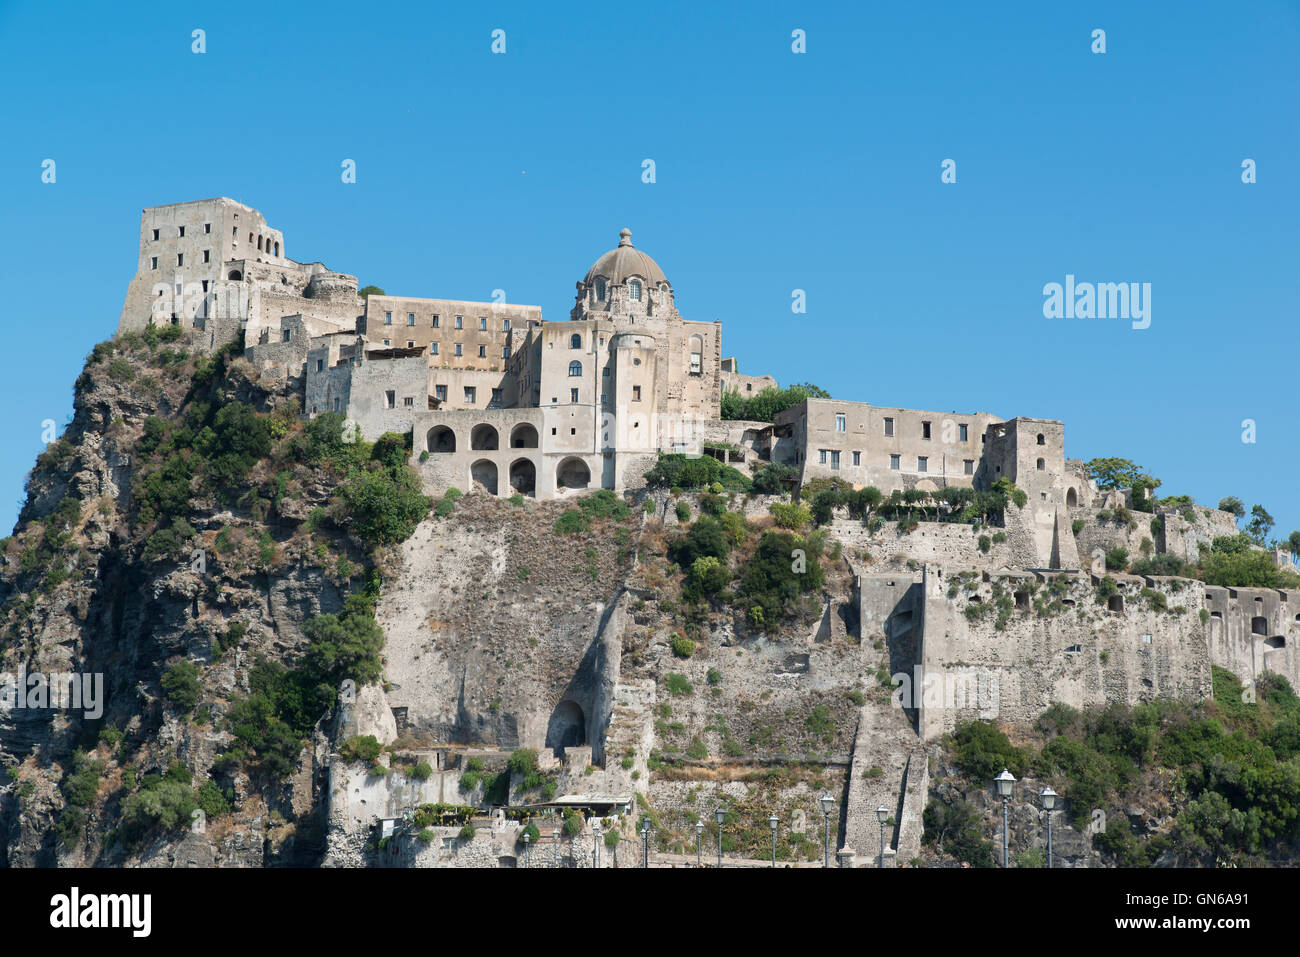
[0,0,1300,536]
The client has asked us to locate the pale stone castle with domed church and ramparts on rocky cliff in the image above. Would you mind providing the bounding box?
[111,199,1300,854]
